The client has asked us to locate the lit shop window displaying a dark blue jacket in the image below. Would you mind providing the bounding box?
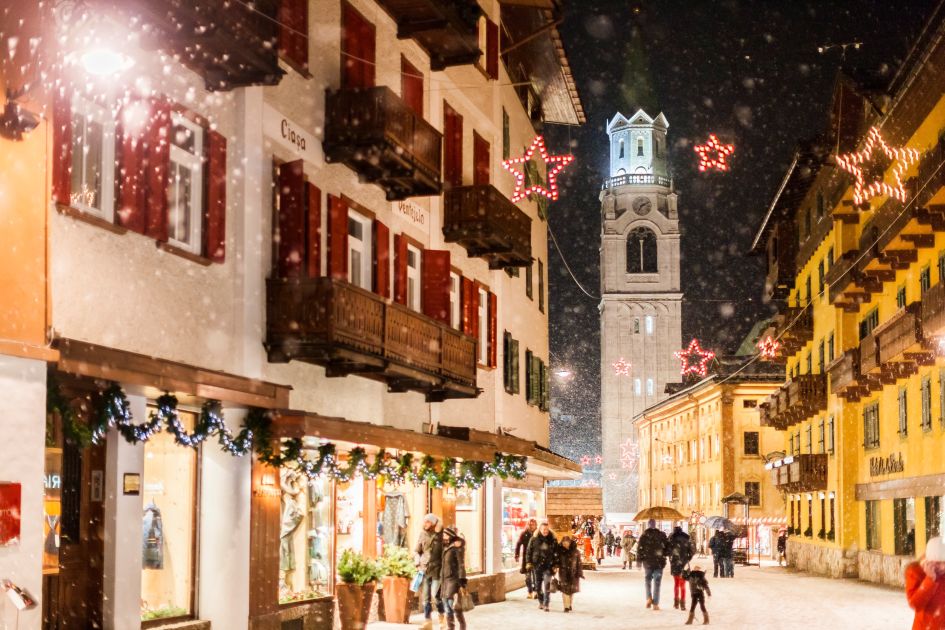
[141,409,200,621]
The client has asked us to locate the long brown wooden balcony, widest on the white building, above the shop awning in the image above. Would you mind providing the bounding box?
[265,278,479,402]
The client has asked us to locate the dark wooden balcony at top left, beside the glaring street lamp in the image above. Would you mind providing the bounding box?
[115,0,285,90]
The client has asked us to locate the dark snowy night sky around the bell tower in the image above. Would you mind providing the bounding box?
[545,0,937,458]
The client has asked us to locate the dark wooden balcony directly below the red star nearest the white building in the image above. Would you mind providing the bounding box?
[443,185,532,269]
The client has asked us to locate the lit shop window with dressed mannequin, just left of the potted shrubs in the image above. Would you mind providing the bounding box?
[278,468,334,604]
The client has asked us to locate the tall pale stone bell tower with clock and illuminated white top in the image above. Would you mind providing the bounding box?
[600,109,682,515]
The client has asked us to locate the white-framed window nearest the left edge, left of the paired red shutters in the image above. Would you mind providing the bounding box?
[63,97,115,221]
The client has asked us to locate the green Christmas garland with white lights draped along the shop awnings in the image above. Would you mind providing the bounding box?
[46,379,526,488]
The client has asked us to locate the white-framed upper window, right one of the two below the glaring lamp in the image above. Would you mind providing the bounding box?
[167,112,204,254]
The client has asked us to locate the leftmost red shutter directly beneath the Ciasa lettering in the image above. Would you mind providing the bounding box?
[276,160,305,278]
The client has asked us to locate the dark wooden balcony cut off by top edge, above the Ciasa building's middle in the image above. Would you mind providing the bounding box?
[378,0,482,70]
